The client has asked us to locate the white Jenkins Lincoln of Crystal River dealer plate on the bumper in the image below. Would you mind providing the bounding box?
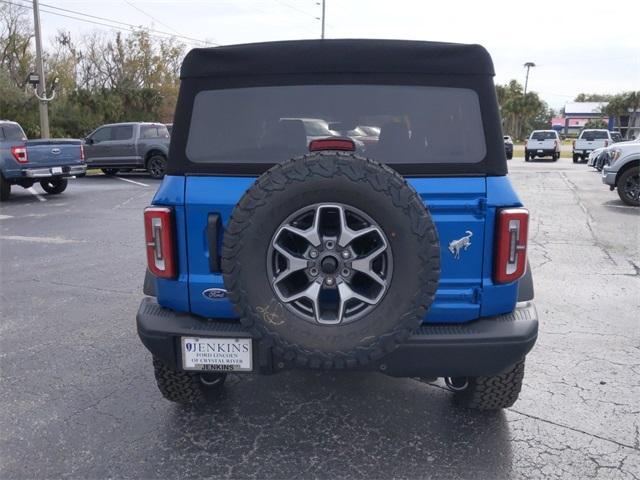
[182,337,253,372]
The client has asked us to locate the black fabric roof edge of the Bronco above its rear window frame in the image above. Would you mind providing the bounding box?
[180,40,495,79]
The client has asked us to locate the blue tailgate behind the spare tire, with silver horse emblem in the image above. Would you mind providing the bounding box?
[185,176,487,322]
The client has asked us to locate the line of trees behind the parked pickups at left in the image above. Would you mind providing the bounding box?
[0,3,186,137]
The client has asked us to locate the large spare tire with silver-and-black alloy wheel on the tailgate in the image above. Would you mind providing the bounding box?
[222,152,440,369]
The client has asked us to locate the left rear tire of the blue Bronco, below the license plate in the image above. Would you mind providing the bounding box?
[153,358,227,405]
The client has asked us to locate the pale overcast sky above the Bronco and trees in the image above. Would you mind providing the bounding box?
[22,0,640,109]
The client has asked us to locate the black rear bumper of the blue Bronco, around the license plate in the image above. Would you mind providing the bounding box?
[136,297,538,377]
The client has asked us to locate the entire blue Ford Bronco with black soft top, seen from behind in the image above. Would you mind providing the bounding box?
[137,40,538,410]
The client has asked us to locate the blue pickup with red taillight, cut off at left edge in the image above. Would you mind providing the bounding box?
[0,120,87,202]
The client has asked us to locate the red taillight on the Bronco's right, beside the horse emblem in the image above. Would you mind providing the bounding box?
[493,208,529,283]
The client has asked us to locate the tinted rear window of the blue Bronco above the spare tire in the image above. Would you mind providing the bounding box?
[186,85,487,164]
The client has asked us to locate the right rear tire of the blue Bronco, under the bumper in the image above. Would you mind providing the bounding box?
[447,360,524,410]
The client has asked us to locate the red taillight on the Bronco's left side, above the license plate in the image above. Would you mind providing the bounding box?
[144,207,177,278]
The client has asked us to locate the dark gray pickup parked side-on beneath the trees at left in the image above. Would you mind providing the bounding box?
[85,122,169,178]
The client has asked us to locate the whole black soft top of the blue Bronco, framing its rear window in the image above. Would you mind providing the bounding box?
[167,39,507,176]
